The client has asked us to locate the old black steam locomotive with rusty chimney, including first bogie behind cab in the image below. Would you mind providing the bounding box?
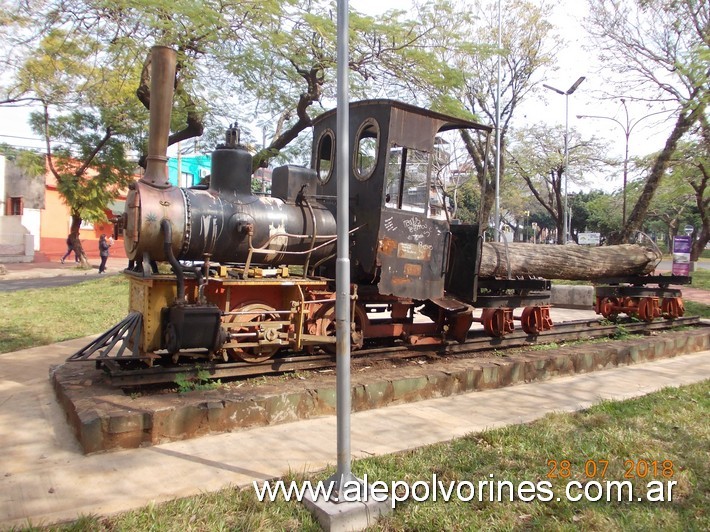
[69,47,552,364]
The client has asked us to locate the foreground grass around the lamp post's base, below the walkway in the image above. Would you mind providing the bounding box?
[25,381,710,531]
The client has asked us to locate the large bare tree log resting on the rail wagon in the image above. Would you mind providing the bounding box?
[479,242,661,281]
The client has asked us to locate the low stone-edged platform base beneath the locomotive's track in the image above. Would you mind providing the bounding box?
[50,327,710,454]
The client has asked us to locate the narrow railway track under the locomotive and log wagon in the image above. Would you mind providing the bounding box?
[96,317,700,387]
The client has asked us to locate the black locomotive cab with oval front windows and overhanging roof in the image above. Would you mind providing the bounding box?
[312,100,491,300]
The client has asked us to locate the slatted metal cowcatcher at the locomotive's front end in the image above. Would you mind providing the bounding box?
[67,312,152,362]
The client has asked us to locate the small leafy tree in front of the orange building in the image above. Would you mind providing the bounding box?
[18,30,143,265]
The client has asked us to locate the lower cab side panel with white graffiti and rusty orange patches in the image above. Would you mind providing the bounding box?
[377,211,449,300]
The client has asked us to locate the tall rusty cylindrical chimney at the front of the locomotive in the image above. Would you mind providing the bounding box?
[141,46,177,188]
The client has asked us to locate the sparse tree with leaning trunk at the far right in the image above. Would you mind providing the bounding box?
[587,0,710,241]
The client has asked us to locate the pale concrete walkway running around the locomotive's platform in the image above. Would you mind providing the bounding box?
[0,332,710,527]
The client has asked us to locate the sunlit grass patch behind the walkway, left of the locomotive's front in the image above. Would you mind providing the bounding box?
[0,276,128,353]
